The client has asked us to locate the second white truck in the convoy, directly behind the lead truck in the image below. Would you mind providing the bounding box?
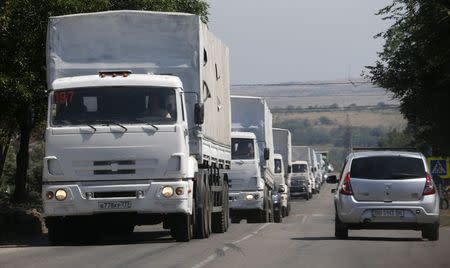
[229,96,274,223]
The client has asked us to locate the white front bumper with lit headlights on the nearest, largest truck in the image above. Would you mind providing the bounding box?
[42,180,193,217]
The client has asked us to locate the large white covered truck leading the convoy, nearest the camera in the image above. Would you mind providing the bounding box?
[42,11,231,244]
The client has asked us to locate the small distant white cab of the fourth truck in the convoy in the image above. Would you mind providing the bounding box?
[290,161,313,200]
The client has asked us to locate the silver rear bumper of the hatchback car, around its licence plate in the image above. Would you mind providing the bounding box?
[336,195,439,224]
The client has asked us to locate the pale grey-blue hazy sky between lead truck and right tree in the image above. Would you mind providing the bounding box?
[208,0,392,85]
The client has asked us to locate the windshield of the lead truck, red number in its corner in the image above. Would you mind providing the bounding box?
[51,87,177,126]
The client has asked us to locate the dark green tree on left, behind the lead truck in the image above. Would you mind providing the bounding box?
[0,0,208,201]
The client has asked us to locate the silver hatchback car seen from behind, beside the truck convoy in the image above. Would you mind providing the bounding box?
[327,151,439,241]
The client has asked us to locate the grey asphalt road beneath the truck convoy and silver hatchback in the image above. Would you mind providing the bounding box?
[0,186,450,268]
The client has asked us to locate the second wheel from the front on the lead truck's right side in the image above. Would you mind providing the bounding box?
[194,174,212,239]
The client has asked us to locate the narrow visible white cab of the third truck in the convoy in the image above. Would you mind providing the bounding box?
[274,154,290,219]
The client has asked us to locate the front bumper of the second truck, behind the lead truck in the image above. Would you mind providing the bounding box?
[228,191,264,210]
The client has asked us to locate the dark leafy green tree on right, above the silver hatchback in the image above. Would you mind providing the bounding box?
[368,0,450,155]
